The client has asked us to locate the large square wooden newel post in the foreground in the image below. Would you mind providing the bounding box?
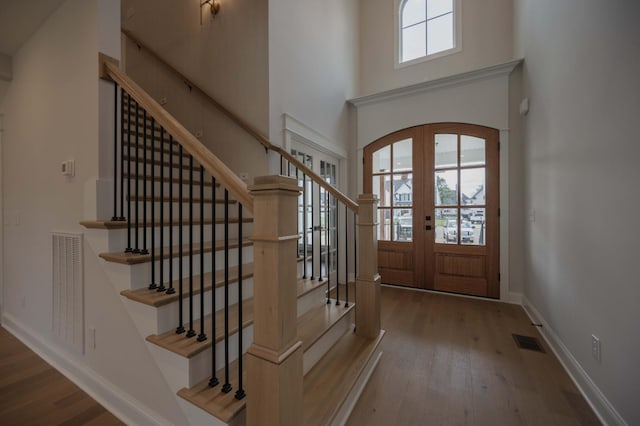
[246,176,303,426]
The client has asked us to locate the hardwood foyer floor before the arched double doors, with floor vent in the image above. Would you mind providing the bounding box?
[347,287,600,426]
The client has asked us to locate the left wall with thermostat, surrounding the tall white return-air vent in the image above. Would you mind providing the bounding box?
[0,0,185,424]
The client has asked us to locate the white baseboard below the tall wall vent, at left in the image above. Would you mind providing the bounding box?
[2,314,171,426]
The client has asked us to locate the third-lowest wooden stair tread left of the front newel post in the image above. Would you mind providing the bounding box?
[120,263,253,308]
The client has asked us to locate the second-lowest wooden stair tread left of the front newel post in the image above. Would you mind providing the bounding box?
[147,299,253,358]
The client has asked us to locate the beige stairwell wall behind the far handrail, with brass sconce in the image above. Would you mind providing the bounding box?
[122,0,269,181]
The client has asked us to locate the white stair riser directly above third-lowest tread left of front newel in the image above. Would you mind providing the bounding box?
[105,246,253,291]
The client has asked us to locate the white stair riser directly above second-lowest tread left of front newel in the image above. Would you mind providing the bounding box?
[124,278,253,338]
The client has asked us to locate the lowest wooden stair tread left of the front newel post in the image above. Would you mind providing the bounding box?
[178,360,247,423]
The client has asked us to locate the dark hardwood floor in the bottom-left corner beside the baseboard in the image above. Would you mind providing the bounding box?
[0,328,124,426]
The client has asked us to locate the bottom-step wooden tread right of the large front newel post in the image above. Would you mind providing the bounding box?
[303,330,385,426]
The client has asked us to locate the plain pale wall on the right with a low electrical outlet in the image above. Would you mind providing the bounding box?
[515,0,640,425]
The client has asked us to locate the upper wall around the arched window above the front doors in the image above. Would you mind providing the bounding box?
[360,0,513,95]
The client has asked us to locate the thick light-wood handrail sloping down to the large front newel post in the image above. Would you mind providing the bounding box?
[100,55,253,212]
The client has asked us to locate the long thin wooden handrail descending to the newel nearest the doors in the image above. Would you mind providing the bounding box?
[122,29,358,213]
